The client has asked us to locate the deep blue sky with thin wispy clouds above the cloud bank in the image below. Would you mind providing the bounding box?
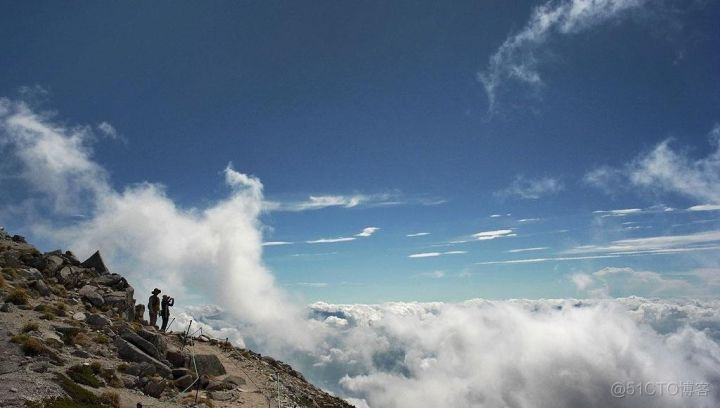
[0,0,720,303]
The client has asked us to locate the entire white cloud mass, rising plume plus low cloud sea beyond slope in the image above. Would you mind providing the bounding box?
[0,94,720,408]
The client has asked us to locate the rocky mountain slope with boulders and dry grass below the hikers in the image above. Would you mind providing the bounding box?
[0,230,351,408]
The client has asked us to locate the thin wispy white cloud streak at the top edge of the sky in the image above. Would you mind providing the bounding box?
[478,0,646,111]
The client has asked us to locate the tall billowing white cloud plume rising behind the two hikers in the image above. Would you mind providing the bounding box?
[0,99,315,348]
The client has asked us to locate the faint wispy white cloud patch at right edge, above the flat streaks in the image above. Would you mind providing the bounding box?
[585,125,720,204]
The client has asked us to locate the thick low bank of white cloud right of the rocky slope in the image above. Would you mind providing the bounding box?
[303,298,720,408]
